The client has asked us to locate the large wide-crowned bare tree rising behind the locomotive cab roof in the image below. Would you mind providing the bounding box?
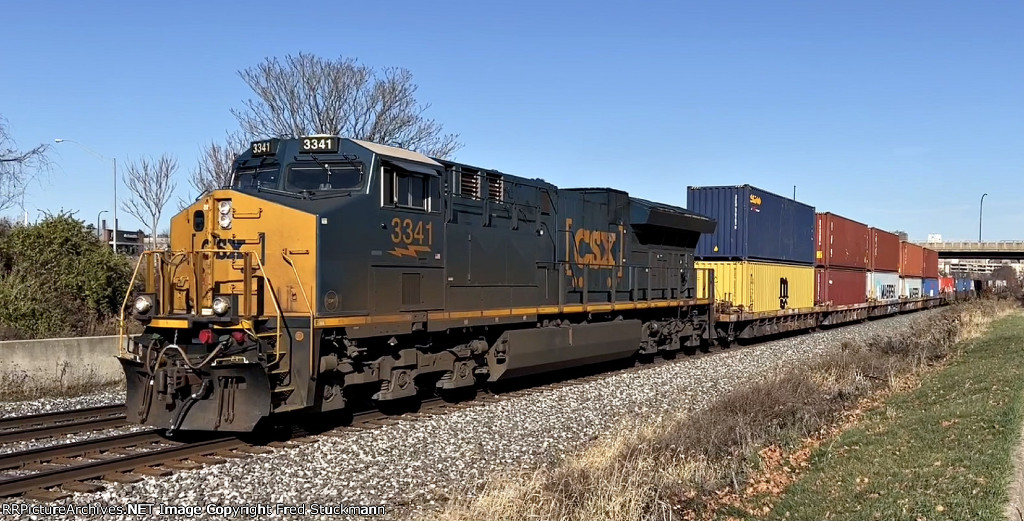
[231,53,462,158]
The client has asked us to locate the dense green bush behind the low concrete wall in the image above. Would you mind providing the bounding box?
[0,214,131,339]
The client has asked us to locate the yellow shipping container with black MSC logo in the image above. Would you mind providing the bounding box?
[694,261,814,313]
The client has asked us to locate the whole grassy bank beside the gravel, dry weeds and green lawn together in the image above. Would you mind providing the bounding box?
[439,301,1024,520]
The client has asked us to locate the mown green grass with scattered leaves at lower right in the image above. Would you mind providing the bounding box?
[771,315,1024,521]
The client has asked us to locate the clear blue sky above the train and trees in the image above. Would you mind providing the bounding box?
[0,0,1024,240]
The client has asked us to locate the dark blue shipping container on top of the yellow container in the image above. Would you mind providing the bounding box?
[686,184,815,265]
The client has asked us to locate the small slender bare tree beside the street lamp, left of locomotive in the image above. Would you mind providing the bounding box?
[121,154,178,249]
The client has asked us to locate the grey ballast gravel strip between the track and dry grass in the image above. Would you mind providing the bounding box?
[0,311,935,519]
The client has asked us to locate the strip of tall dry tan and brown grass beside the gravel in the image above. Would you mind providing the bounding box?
[438,301,1019,521]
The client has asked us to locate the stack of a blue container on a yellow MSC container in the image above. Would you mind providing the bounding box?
[686,184,815,313]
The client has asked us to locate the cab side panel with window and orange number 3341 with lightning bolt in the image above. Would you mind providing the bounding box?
[370,159,444,314]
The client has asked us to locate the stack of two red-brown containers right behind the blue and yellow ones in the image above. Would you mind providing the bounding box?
[814,212,870,306]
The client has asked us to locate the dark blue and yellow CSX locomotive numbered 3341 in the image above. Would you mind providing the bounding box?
[119,136,715,431]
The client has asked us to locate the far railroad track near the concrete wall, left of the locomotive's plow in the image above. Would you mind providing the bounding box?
[0,404,128,443]
